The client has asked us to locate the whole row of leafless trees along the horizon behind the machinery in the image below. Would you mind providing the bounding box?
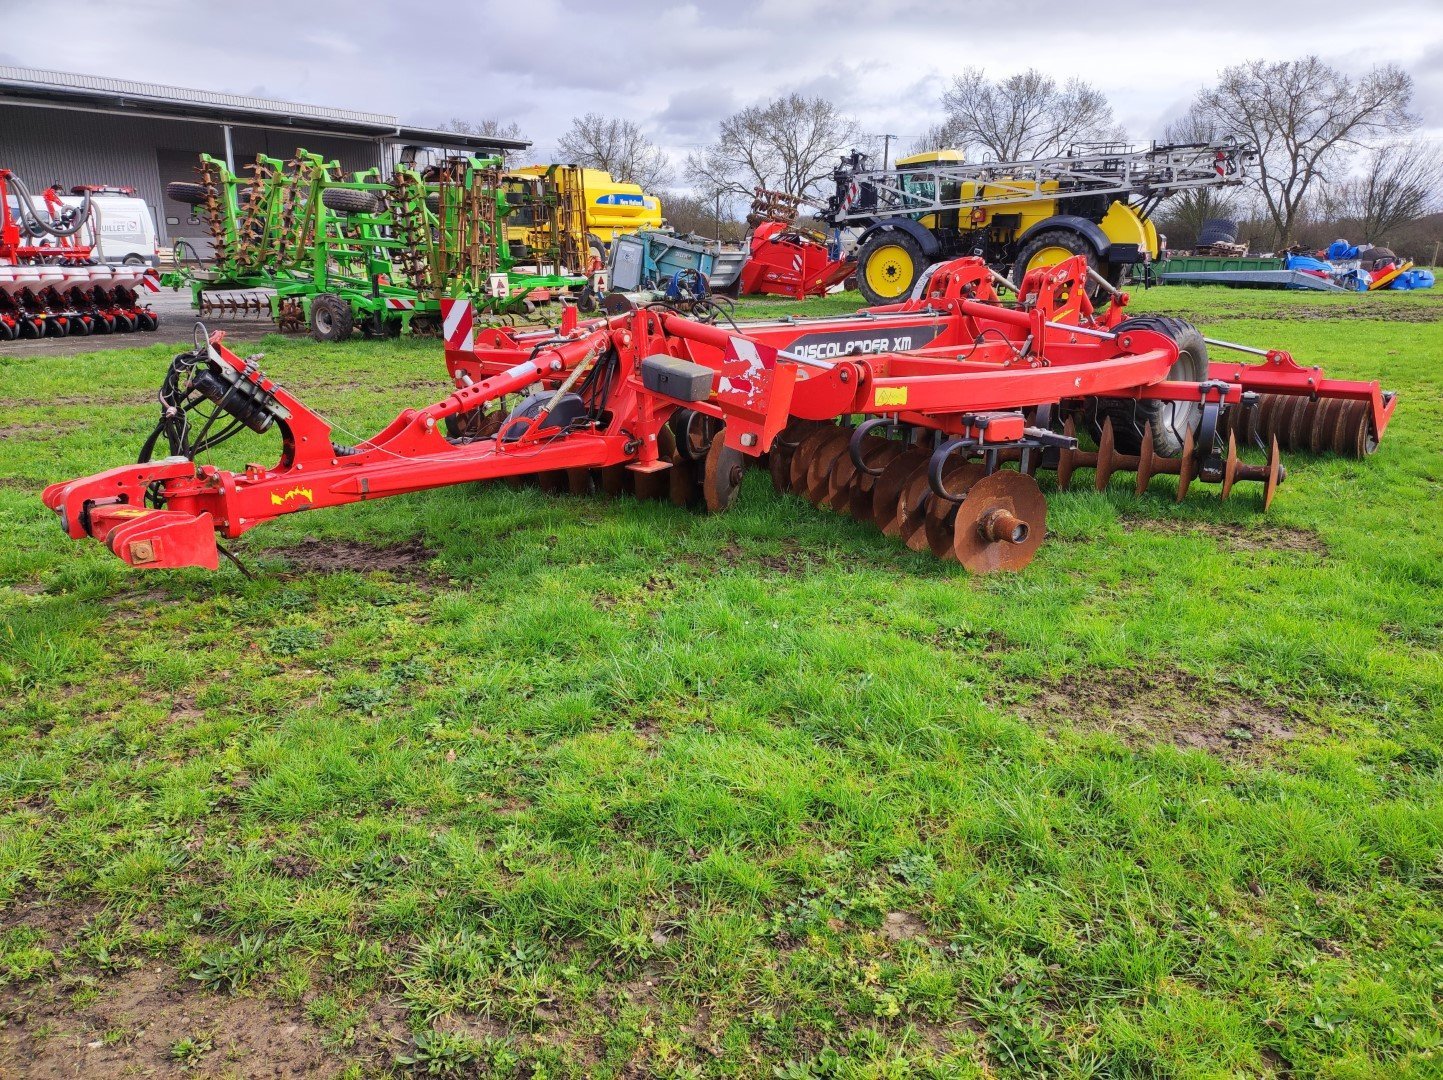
[452,56,1443,257]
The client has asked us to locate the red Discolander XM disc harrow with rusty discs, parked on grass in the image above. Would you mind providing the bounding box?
[43,258,1395,572]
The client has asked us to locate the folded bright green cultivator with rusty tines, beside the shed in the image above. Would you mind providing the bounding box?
[162,150,592,341]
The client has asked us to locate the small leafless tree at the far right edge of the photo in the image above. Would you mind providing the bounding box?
[1323,141,1443,244]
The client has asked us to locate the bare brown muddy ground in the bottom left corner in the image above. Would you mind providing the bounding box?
[0,963,336,1080]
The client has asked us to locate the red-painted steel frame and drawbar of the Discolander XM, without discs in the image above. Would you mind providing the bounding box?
[43,258,1394,569]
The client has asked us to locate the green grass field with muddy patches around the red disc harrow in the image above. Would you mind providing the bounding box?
[0,282,1443,1079]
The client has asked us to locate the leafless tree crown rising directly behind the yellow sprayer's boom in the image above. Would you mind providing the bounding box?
[928,68,1123,162]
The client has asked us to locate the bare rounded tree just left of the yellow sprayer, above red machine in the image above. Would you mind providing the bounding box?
[687,94,859,198]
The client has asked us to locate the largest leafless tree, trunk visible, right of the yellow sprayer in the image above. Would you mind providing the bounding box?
[1195,56,1416,245]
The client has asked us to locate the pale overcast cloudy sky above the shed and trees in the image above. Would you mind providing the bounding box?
[0,0,1443,176]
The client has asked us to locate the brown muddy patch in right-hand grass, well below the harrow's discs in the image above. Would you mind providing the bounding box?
[1010,669,1306,758]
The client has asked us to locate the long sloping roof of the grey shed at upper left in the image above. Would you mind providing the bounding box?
[0,65,531,150]
